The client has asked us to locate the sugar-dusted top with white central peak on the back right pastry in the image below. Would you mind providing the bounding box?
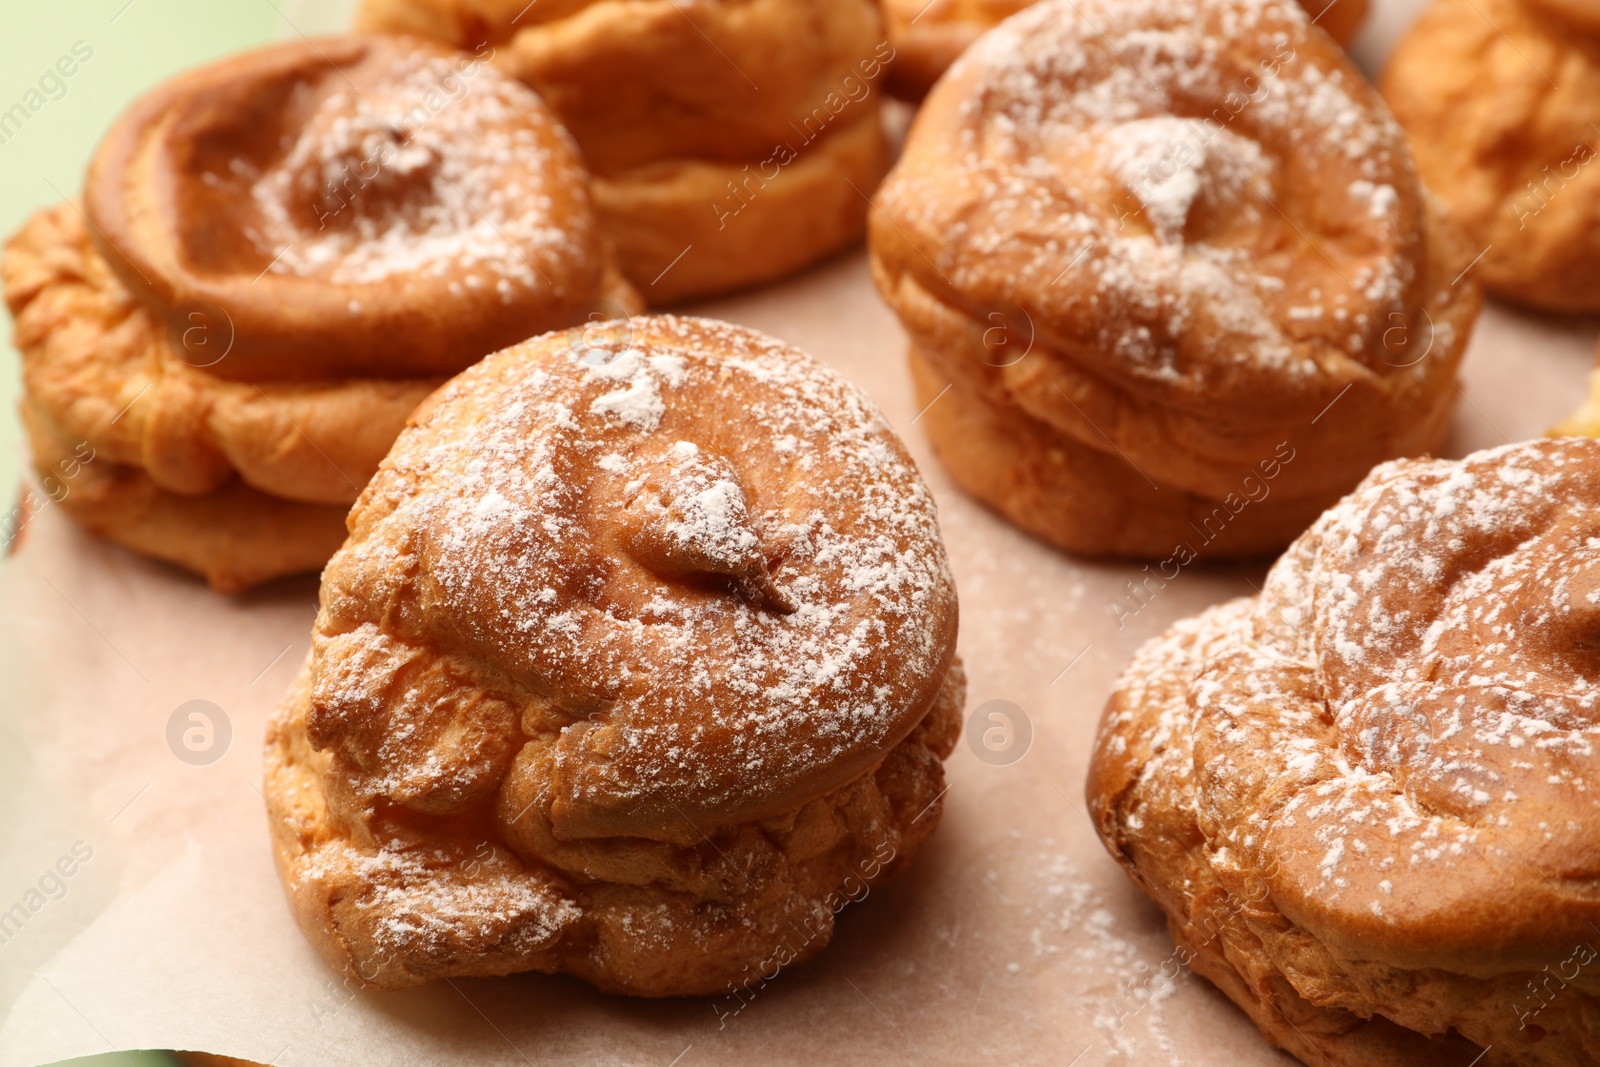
[872,0,1451,421]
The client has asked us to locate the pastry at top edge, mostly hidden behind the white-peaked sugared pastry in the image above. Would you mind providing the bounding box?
[878,0,1369,101]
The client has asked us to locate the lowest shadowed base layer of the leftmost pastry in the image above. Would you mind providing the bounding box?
[22,403,347,593]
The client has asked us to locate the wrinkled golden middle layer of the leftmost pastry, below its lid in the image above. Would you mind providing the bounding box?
[3,202,438,507]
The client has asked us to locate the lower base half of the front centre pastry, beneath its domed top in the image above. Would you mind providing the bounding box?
[264,659,965,997]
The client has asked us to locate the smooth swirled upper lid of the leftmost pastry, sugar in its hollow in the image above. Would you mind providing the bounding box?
[85,37,606,379]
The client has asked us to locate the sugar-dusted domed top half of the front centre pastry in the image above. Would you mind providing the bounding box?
[309,317,957,840]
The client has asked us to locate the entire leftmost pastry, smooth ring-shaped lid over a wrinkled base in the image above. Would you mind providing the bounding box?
[12,37,637,590]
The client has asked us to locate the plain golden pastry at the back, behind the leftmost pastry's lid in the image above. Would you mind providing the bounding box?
[357,0,891,306]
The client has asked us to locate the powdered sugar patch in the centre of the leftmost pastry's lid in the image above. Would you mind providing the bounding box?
[253,48,582,292]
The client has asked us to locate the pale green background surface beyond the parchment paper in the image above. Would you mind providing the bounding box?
[0,8,347,1067]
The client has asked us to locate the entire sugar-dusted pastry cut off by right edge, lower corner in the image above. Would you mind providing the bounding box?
[1088,438,1600,1067]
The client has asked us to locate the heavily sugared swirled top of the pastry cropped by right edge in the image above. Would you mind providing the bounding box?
[1177,438,1600,971]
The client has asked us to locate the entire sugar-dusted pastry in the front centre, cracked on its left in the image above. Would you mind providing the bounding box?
[266,317,965,997]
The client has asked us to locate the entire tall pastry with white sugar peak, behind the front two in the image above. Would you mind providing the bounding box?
[869,0,1480,566]
